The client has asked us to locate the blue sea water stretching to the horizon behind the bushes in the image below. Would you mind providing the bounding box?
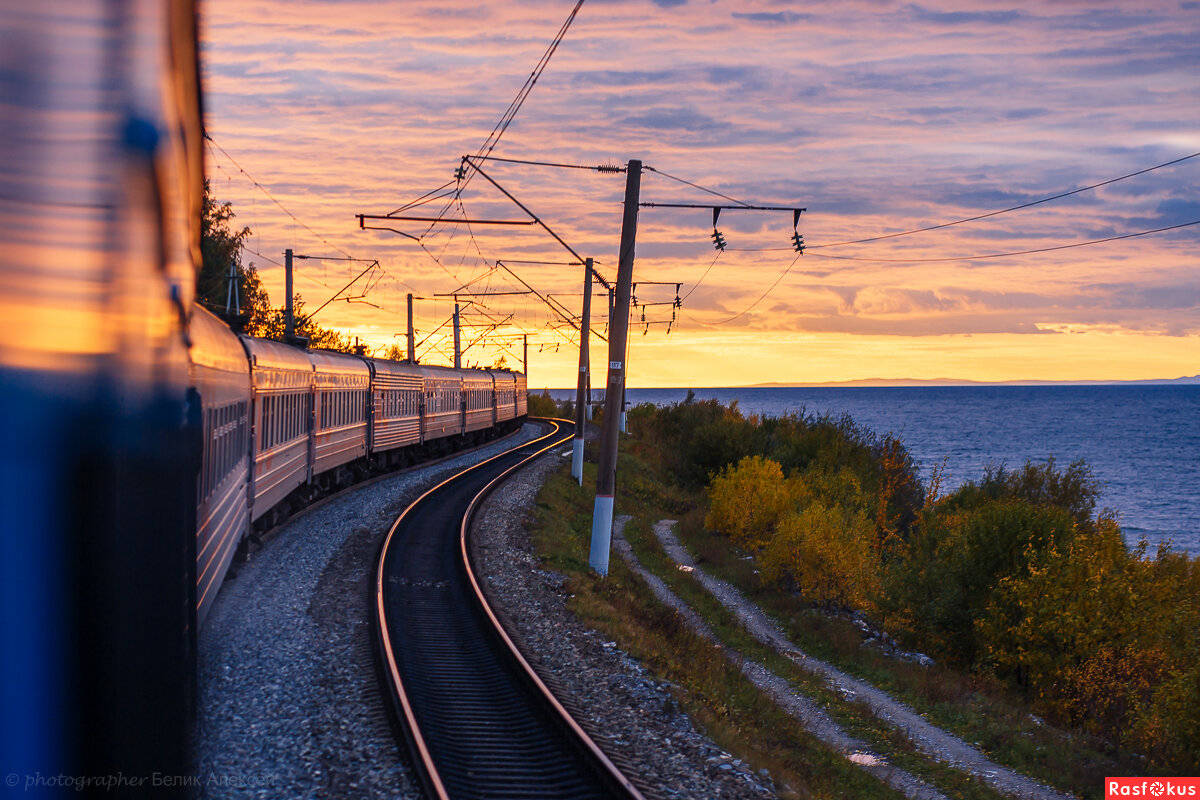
[551,385,1200,557]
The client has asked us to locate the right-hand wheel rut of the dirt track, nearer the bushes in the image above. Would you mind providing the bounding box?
[654,519,1070,800]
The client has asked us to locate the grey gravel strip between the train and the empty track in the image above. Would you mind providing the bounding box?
[194,425,540,800]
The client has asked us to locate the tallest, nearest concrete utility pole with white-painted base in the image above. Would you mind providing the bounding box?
[588,158,642,576]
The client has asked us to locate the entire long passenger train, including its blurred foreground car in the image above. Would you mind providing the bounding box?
[0,0,526,798]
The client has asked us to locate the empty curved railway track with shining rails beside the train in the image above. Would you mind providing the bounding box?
[376,421,641,799]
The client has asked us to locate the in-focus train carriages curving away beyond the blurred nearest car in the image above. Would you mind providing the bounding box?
[190,306,528,625]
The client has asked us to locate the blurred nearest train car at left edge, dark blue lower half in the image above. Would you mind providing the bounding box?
[0,0,206,798]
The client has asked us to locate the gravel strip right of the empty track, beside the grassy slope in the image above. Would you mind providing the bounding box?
[472,445,774,799]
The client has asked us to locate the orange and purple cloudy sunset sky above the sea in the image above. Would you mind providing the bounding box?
[200,0,1200,387]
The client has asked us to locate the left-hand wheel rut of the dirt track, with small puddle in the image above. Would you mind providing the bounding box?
[612,517,947,800]
